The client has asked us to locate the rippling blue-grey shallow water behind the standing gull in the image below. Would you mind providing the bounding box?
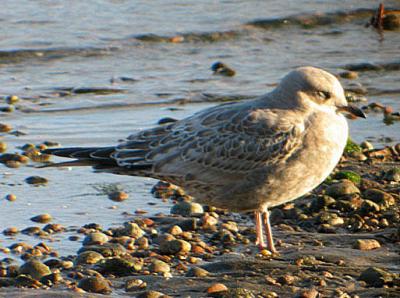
[0,0,400,254]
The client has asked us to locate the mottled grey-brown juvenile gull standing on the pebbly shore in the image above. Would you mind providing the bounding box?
[44,67,365,252]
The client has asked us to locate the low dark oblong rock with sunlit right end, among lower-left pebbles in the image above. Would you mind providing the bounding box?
[96,257,143,276]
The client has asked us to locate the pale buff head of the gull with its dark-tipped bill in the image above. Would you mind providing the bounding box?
[276,66,365,118]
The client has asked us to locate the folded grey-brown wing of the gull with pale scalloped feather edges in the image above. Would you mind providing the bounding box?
[112,104,304,182]
